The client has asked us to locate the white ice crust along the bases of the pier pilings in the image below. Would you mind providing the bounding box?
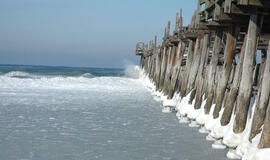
[137,67,270,160]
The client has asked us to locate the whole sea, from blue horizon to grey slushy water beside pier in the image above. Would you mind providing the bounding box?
[0,65,226,160]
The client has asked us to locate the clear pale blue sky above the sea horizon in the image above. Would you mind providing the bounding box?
[0,0,197,68]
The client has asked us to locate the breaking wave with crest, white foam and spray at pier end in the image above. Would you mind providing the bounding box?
[0,66,142,91]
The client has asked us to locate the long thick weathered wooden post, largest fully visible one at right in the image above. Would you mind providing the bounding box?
[233,15,259,133]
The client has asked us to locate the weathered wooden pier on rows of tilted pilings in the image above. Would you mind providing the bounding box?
[136,0,270,158]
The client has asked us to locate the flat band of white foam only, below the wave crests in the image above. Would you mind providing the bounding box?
[0,74,139,92]
